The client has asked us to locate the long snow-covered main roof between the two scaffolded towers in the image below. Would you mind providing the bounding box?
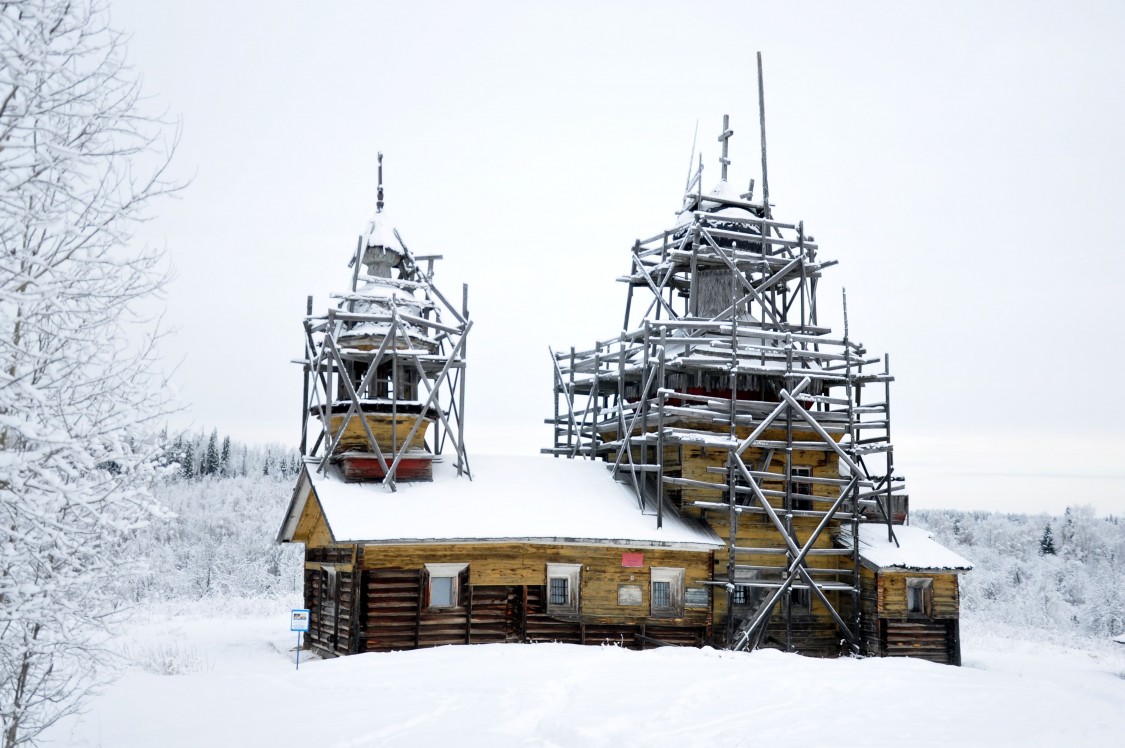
[278,456,722,550]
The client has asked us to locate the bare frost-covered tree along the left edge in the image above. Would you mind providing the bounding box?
[0,0,172,748]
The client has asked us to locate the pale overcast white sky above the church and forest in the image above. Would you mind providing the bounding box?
[111,0,1125,512]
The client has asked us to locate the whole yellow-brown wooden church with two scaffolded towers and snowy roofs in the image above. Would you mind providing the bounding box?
[278,74,971,664]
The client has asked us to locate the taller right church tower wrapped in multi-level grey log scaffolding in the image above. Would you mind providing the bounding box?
[543,56,905,651]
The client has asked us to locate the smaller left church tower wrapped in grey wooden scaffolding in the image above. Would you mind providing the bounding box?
[298,153,473,490]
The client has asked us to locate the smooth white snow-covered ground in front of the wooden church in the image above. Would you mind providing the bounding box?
[45,601,1125,748]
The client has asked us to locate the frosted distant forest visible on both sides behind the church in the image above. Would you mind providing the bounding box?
[127,431,1125,638]
